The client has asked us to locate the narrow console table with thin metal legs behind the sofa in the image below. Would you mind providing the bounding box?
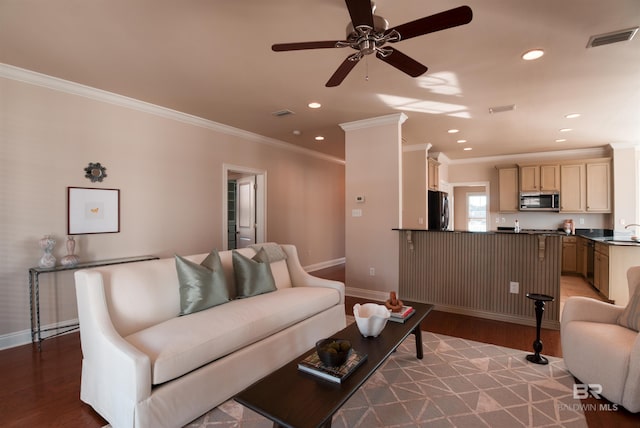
[29,256,159,350]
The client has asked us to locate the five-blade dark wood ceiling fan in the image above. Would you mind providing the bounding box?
[271,0,473,87]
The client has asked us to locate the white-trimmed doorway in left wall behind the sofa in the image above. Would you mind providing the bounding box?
[222,164,267,250]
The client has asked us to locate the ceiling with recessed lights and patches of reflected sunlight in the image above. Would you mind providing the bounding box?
[0,0,640,159]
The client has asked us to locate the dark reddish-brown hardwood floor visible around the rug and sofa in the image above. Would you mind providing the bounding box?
[0,266,640,428]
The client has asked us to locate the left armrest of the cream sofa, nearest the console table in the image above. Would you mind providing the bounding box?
[74,270,151,412]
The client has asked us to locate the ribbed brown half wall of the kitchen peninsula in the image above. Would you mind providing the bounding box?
[394,229,562,329]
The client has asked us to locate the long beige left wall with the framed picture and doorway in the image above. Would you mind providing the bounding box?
[0,75,345,347]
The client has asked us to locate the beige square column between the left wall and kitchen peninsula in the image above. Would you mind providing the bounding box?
[341,114,406,297]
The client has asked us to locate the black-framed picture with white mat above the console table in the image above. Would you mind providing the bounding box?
[67,187,120,235]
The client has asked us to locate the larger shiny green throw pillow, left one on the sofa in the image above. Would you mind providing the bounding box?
[176,250,231,315]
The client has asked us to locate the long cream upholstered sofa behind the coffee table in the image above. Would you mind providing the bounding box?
[75,245,346,428]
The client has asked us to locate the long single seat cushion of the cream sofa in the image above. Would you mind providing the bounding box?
[125,287,340,385]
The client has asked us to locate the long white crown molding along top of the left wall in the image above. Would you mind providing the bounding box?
[0,63,345,165]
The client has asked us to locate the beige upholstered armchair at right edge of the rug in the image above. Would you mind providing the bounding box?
[560,266,640,413]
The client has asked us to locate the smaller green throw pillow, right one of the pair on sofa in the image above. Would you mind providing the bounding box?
[231,250,276,299]
